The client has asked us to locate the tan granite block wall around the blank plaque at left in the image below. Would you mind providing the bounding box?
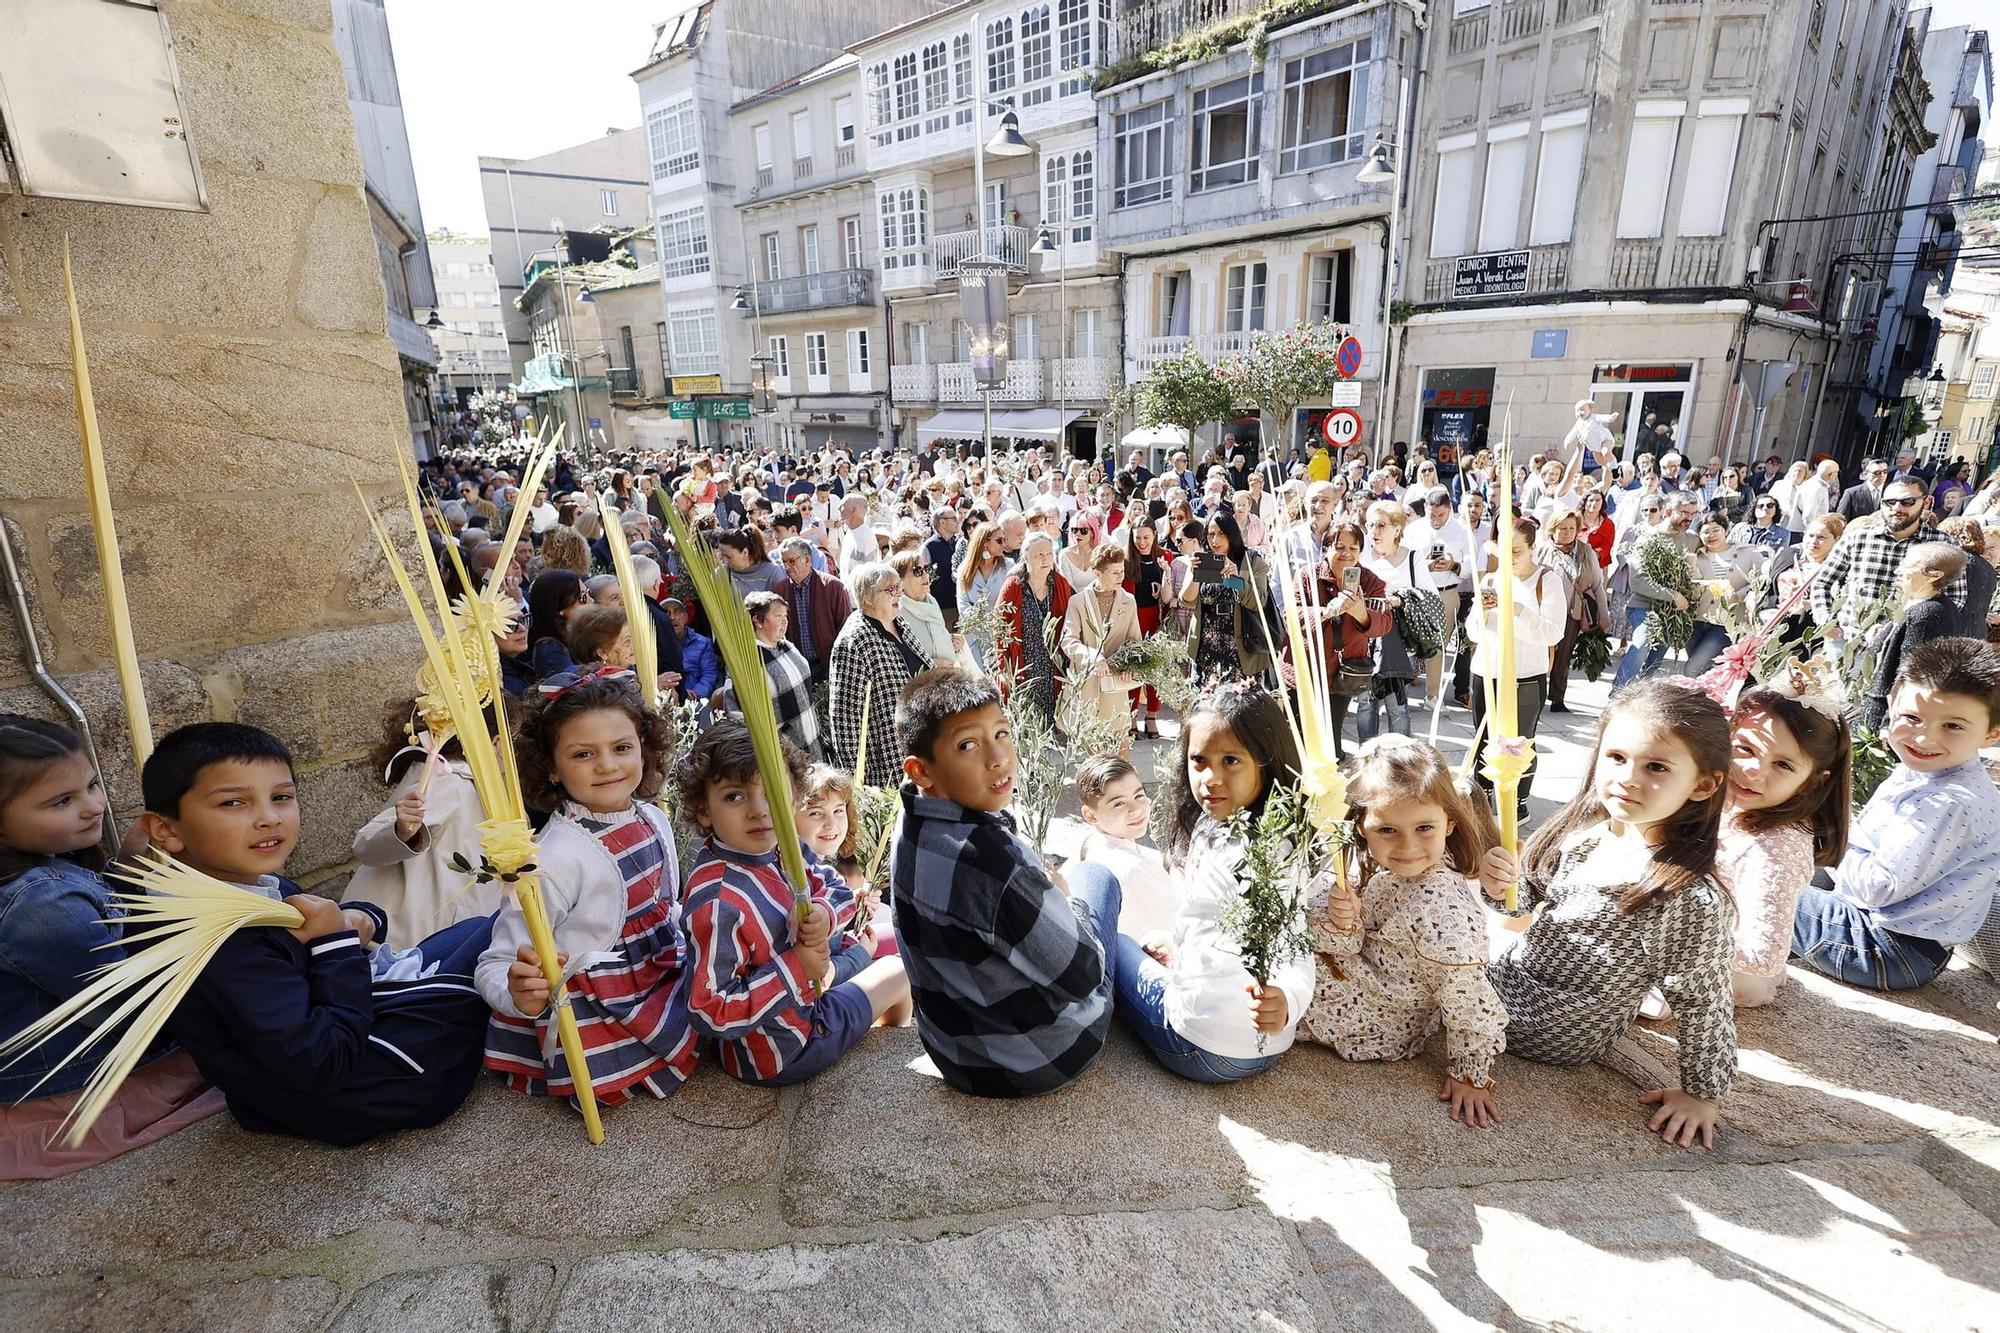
[0,0,418,883]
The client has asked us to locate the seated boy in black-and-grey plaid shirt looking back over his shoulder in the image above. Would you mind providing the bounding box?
[890,667,1112,1097]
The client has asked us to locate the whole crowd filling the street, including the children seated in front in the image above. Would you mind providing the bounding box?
[0,418,2000,1177]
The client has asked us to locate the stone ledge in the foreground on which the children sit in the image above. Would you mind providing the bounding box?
[0,691,2000,1333]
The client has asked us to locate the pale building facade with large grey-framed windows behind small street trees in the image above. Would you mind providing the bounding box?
[1098,4,1418,462]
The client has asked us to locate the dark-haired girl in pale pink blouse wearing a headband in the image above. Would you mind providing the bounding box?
[1716,669,1854,1009]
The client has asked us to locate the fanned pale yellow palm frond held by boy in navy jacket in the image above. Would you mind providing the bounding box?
[0,851,306,1147]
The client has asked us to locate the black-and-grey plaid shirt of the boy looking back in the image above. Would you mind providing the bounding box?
[890,783,1112,1097]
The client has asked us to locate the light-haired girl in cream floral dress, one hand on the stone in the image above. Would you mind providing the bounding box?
[1298,735,1512,1129]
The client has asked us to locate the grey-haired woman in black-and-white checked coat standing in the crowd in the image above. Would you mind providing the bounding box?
[826,560,930,787]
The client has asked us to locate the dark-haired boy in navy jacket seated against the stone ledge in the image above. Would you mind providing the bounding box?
[140,723,492,1147]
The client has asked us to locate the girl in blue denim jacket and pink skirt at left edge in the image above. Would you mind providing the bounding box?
[0,713,222,1181]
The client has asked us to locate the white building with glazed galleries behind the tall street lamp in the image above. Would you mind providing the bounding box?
[854,0,1122,458]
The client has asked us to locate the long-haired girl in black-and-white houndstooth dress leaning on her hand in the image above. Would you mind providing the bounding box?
[1488,681,1736,1147]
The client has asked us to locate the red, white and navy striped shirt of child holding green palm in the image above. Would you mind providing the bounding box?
[686,837,854,1081]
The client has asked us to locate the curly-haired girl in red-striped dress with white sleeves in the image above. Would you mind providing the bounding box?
[474,671,696,1107]
